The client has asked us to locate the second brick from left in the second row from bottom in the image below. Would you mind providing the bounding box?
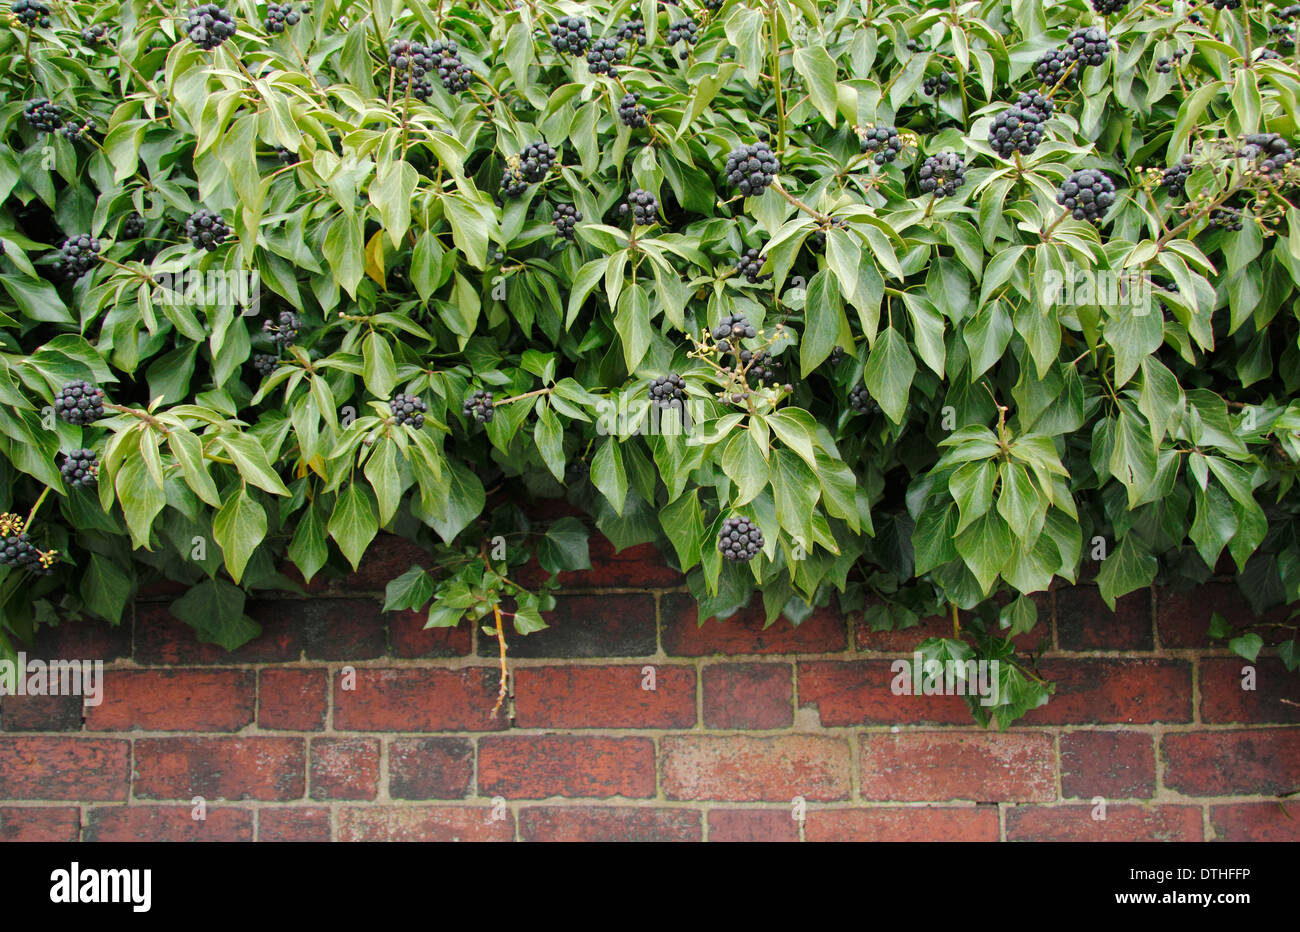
[135,737,306,801]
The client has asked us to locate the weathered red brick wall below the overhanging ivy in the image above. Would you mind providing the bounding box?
[0,530,1300,841]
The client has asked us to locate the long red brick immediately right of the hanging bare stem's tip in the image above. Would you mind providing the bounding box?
[515,664,696,728]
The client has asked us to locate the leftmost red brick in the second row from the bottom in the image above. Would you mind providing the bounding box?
[0,737,131,801]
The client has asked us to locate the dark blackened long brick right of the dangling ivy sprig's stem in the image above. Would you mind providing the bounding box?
[478,593,658,659]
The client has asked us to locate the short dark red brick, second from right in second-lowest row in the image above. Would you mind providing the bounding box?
[1061,732,1156,799]
